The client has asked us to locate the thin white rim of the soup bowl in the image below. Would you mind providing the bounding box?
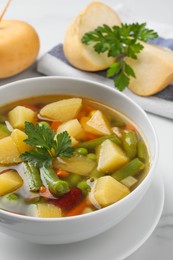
[0,76,159,223]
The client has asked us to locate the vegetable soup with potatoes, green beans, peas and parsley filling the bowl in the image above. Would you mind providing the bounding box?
[0,96,149,218]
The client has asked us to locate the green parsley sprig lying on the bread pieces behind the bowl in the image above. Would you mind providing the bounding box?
[82,23,158,91]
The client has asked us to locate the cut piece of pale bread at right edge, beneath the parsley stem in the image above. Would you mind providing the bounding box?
[126,42,173,96]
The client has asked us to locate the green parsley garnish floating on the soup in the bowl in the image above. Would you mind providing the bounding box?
[20,122,74,168]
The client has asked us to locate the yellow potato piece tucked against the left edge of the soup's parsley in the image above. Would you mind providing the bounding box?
[11,129,32,154]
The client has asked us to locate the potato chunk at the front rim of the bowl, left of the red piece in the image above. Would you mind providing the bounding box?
[29,203,62,218]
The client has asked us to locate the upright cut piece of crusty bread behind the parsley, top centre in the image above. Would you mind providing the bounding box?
[64,2,121,71]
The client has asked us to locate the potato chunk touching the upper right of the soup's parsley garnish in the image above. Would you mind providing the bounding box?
[57,119,84,140]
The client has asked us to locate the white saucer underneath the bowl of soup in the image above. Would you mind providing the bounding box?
[0,175,164,260]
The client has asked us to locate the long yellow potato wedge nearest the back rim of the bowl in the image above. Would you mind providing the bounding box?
[40,98,82,122]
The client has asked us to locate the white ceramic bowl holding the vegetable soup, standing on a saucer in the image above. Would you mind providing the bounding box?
[0,77,158,244]
